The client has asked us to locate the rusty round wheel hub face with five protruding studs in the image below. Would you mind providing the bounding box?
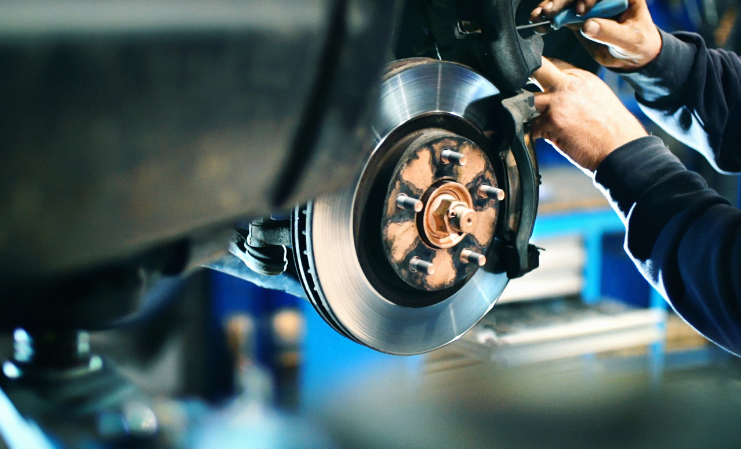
[381,128,499,291]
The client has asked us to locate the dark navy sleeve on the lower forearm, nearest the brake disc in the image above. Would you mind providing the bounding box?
[595,137,741,354]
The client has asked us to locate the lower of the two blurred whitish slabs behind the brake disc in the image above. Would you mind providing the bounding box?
[428,299,666,370]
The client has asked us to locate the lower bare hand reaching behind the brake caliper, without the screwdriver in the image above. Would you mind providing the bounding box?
[531,58,648,172]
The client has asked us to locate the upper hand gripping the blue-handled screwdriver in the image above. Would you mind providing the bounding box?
[572,0,662,70]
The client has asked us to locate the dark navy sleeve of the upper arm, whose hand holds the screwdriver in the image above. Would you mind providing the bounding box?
[621,31,741,172]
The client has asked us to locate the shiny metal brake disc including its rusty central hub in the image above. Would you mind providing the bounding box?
[293,60,529,354]
